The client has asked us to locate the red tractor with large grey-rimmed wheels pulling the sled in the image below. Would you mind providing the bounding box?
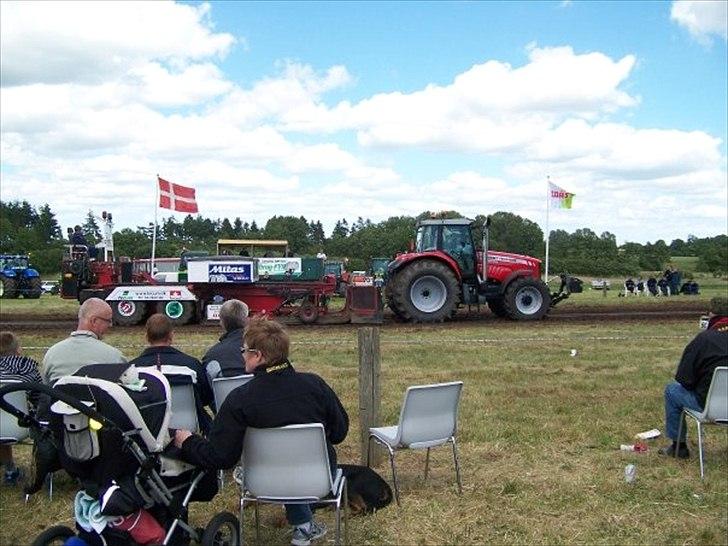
[385,218,581,322]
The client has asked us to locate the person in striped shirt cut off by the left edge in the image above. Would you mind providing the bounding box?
[0,332,42,485]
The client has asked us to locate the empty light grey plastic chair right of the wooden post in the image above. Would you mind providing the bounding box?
[367,381,463,504]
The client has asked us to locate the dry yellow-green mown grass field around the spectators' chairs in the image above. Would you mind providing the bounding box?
[0,298,728,546]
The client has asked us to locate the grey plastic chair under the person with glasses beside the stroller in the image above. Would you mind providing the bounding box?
[240,423,348,544]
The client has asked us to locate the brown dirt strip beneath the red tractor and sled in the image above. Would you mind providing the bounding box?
[0,298,705,332]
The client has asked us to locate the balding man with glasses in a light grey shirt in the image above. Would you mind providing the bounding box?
[42,298,126,385]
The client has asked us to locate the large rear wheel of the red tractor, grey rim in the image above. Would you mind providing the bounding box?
[387,260,460,322]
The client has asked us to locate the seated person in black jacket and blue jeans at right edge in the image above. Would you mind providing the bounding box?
[659,298,728,459]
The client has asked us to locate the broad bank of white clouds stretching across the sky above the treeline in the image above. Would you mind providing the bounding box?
[0,2,727,240]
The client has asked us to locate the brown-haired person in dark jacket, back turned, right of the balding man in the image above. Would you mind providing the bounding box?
[131,313,212,434]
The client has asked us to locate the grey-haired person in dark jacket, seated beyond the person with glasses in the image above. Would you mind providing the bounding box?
[202,300,248,383]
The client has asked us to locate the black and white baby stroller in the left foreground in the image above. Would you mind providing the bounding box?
[0,364,239,546]
